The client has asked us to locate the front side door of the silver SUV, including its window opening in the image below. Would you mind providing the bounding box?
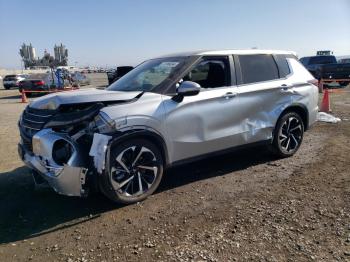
[163,56,239,162]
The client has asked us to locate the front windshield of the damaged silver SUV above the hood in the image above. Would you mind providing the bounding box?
[107,57,185,92]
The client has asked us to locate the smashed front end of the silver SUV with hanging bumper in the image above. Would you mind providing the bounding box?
[18,103,114,196]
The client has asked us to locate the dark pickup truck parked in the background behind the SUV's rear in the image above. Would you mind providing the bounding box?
[300,55,350,86]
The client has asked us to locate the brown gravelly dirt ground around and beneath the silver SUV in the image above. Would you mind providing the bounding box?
[0,74,350,262]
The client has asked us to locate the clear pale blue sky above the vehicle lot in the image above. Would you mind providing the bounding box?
[0,0,350,68]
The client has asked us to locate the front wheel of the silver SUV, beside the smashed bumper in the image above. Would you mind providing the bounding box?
[100,138,164,204]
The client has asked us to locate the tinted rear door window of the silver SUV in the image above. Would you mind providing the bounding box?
[238,55,279,84]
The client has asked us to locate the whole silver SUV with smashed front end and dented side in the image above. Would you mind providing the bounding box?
[18,50,318,203]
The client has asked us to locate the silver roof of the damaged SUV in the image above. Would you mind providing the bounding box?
[159,49,297,58]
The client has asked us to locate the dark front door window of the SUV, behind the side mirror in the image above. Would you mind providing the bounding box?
[183,57,229,88]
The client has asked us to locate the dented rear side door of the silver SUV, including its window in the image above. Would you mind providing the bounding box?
[234,54,294,144]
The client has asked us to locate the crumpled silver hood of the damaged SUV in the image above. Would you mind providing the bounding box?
[29,88,140,110]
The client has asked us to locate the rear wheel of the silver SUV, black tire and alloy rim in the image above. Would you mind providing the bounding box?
[271,112,304,157]
